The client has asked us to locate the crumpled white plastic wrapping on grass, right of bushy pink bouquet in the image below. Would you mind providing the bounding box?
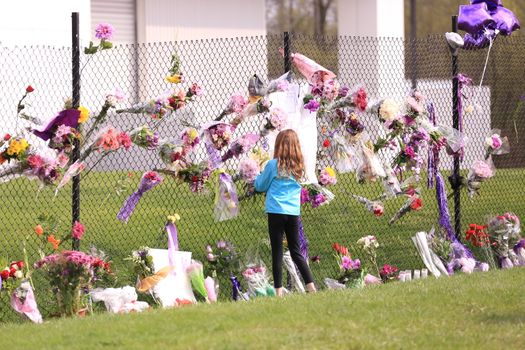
[90,286,149,314]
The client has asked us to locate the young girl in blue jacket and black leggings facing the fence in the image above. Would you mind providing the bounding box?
[255,129,315,296]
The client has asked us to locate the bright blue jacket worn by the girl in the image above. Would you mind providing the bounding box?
[255,159,301,216]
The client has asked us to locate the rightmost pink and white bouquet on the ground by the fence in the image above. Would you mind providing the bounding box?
[487,213,523,269]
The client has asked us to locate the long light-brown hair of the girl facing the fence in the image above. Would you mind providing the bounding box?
[273,129,304,181]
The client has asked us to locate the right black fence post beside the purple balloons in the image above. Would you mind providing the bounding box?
[450,15,461,239]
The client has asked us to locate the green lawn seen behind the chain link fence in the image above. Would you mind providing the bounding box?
[0,169,525,321]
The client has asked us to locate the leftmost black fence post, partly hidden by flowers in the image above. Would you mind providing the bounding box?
[70,12,80,250]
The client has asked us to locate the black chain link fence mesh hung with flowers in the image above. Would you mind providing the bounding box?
[0,36,525,321]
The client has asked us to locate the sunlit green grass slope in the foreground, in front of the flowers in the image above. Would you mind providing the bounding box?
[0,268,525,349]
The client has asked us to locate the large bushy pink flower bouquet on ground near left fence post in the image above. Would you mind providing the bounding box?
[35,250,111,316]
